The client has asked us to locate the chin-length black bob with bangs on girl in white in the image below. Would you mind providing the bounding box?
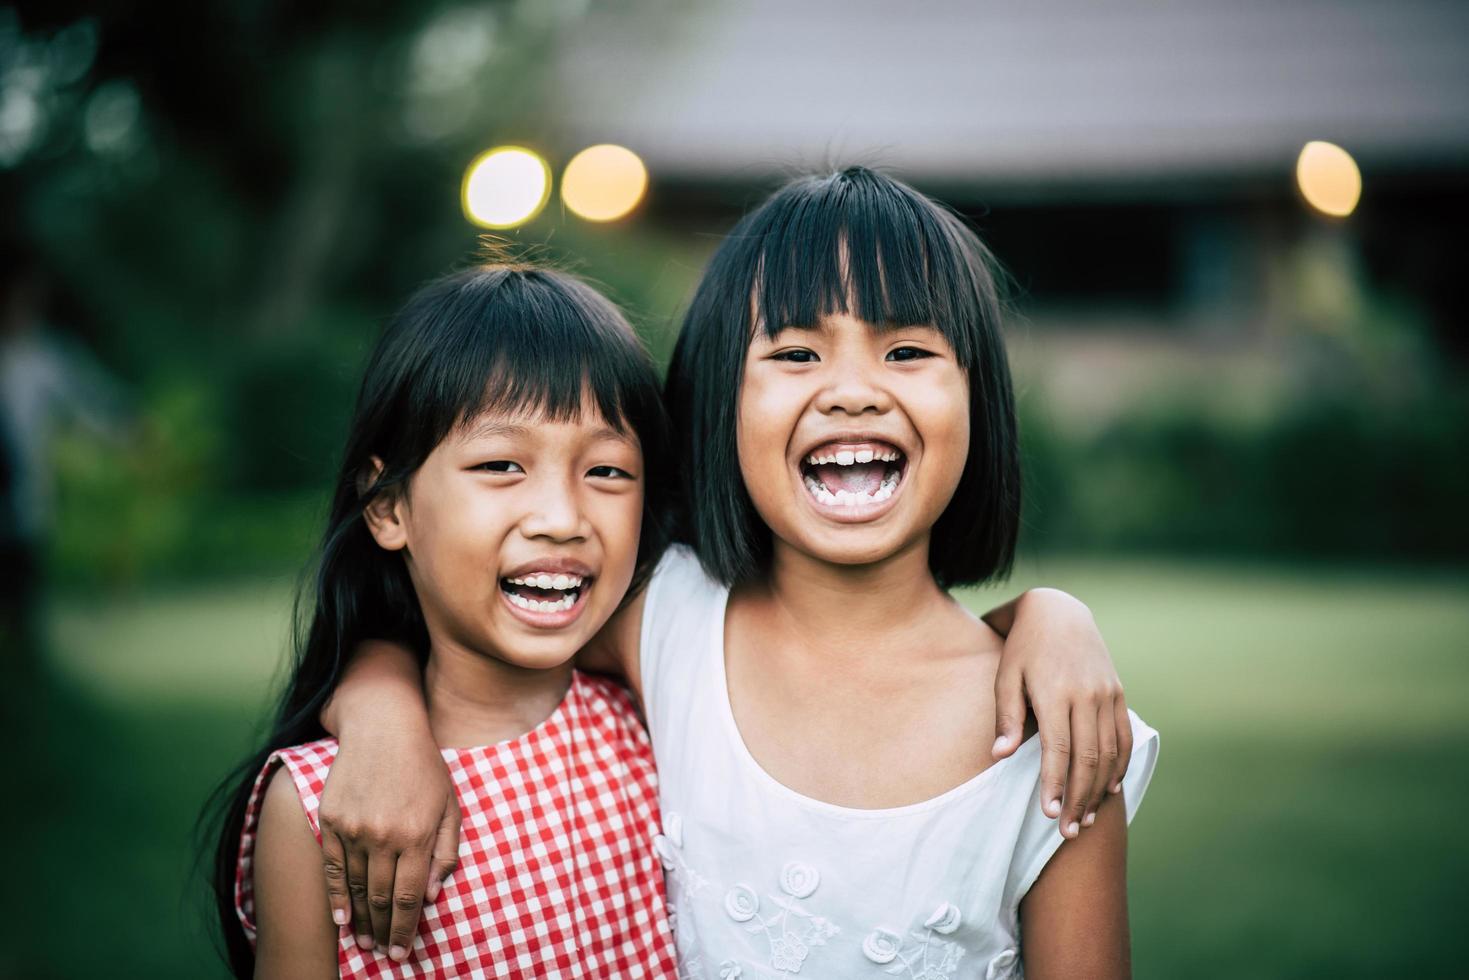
[665,167,1021,588]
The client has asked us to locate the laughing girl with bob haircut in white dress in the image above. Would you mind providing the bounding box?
[324,167,1158,980]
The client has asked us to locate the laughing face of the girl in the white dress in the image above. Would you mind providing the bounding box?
[736,313,970,564]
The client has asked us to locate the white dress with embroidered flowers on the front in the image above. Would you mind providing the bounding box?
[640,547,1158,980]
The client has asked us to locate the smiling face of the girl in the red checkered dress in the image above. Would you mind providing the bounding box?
[366,398,643,669]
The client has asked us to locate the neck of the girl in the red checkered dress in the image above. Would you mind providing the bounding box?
[423,638,571,748]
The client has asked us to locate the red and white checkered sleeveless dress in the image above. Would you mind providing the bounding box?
[235,673,674,977]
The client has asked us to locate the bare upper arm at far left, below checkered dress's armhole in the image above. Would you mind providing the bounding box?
[253,768,338,977]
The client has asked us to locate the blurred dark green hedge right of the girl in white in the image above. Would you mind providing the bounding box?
[1022,391,1469,561]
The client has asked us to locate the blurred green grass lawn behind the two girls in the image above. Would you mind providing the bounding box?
[11,560,1469,979]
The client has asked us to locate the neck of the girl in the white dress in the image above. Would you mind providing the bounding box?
[762,538,950,663]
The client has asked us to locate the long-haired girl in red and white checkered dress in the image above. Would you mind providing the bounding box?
[214,266,674,977]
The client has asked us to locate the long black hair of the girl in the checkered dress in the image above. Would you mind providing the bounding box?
[202,264,668,977]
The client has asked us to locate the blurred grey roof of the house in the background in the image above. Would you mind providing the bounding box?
[549,0,1469,195]
